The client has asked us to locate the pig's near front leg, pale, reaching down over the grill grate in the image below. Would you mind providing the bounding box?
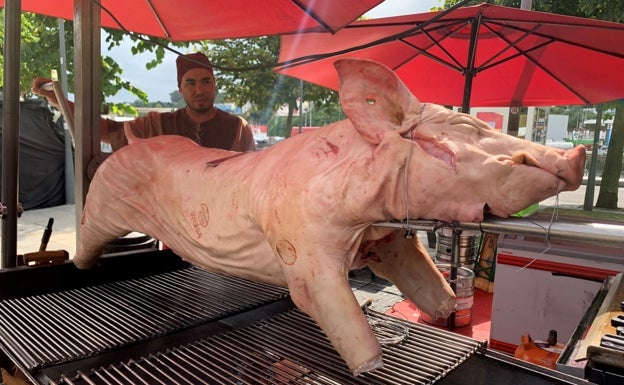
[275,240,383,375]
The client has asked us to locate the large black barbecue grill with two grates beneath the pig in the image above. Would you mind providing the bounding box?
[0,251,586,385]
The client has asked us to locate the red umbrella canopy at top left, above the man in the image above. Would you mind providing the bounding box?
[0,0,383,41]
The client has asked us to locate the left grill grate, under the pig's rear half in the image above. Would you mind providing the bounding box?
[0,266,288,370]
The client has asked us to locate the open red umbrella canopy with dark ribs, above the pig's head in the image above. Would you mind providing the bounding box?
[276,4,624,111]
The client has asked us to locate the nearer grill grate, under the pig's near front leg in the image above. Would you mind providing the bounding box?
[50,309,483,385]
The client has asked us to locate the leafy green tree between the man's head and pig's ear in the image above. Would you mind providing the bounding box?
[200,36,338,137]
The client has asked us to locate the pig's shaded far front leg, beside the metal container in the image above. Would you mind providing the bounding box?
[364,228,455,318]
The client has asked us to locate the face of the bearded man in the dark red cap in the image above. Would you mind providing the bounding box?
[178,68,217,112]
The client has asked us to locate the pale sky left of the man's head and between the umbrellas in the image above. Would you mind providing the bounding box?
[102,0,442,103]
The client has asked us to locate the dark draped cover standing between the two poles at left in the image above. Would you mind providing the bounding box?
[0,100,66,210]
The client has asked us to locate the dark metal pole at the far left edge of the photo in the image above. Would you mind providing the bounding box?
[0,0,22,268]
